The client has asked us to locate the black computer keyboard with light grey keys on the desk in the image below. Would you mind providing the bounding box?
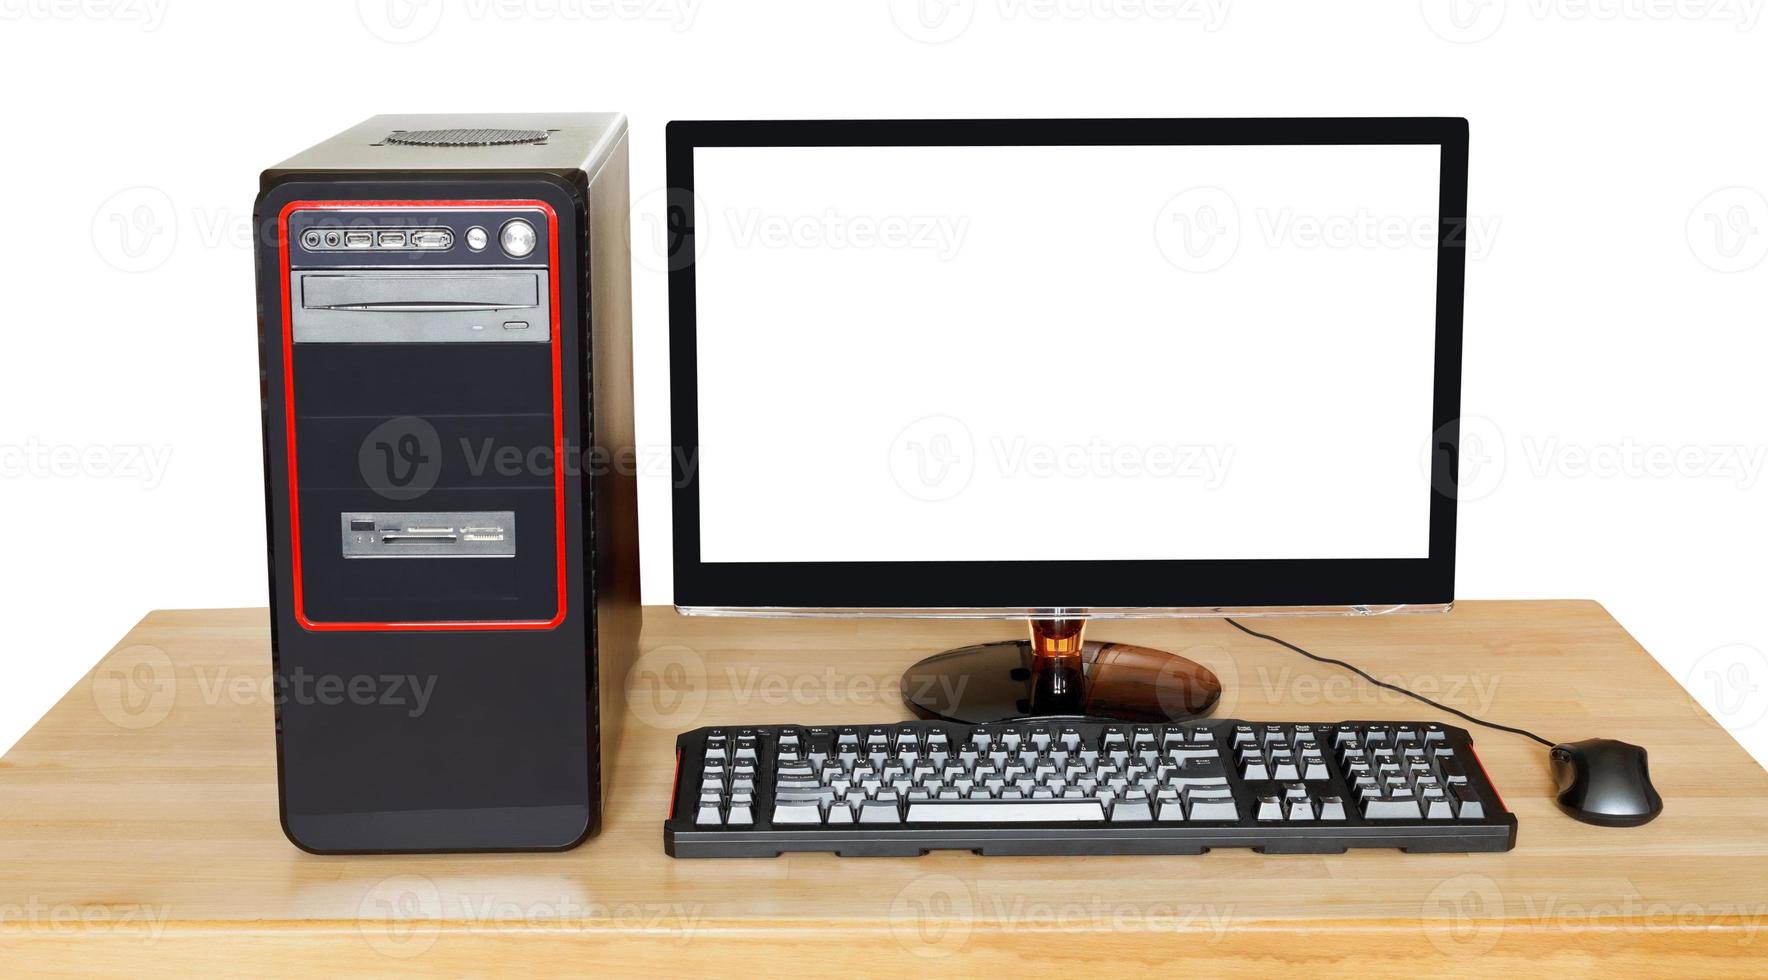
[663,720,1517,858]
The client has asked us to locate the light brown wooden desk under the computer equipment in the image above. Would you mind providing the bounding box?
[0,601,1768,978]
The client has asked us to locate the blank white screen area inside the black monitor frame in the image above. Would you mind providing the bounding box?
[693,145,1441,563]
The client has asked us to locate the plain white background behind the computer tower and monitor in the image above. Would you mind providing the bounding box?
[0,0,1768,759]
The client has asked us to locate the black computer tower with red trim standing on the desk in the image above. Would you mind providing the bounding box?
[255,113,638,853]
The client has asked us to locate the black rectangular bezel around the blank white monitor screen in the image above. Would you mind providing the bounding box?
[667,117,1467,612]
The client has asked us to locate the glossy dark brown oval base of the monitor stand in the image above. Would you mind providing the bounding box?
[902,621,1222,725]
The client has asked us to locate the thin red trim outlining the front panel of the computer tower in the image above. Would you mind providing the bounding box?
[276,200,568,632]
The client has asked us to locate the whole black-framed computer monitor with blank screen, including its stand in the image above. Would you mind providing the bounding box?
[668,119,1467,722]
